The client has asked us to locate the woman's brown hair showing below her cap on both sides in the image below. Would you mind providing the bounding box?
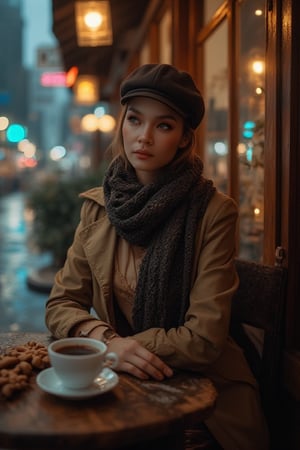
[108,104,195,170]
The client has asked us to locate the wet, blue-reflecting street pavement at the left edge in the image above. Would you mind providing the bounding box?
[0,192,51,332]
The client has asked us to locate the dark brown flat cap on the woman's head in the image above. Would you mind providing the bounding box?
[120,64,205,129]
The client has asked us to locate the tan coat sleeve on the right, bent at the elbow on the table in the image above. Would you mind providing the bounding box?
[134,193,238,371]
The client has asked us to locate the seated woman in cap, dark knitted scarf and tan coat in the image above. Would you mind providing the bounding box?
[46,64,268,450]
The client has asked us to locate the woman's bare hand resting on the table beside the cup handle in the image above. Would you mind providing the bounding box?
[108,337,173,381]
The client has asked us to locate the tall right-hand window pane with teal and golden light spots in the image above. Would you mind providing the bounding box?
[238,0,266,261]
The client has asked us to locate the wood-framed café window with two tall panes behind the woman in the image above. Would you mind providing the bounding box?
[198,0,266,261]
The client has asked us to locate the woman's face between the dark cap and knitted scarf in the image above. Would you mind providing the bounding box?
[122,97,187,184]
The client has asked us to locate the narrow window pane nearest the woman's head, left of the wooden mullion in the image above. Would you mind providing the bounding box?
[203,21,229,192]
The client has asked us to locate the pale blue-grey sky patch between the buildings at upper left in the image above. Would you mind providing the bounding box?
[21,0,56,66]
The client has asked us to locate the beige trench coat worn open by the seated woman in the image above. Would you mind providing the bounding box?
[46,188,268,450]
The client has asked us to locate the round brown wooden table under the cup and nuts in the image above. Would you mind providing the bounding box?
[0,333,216,450]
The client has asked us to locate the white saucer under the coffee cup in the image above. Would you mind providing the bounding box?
[36,367,119,399]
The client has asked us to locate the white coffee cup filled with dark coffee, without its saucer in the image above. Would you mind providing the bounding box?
[48,337,118,389]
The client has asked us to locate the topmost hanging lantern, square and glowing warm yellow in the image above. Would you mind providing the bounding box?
[75,0,113,47]
